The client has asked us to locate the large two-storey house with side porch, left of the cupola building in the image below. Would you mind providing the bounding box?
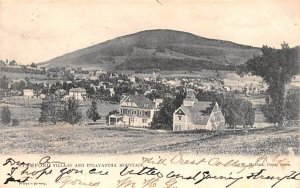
[109,95,157,127]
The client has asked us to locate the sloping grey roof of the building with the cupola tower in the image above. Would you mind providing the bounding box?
[180,101,212,125]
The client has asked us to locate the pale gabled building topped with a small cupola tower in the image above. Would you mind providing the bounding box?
[173,90,225,131]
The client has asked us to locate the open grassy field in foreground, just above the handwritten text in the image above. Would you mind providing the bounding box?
[0,125,299,155]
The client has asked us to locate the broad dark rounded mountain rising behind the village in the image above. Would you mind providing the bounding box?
[44,30,260,70]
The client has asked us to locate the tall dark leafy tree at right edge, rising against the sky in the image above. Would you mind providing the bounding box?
[238,43,300,125]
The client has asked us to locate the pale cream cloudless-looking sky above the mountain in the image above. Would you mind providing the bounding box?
[0,0,300,64]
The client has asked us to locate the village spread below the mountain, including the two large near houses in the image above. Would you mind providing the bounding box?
[0,58,274,131]
